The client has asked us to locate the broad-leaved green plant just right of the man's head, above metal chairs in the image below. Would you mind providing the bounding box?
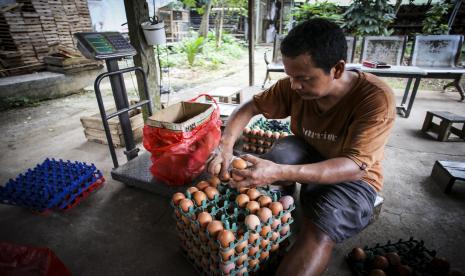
[342,0,395,36]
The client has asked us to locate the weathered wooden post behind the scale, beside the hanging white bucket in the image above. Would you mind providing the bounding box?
[124,0,161,117]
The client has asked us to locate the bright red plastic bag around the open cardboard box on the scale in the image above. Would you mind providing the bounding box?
[143,94,221,186]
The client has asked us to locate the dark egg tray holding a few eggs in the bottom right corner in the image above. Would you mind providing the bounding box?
[346,237,436,276]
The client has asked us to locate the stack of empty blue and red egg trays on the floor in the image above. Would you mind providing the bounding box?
[0,158,104,213]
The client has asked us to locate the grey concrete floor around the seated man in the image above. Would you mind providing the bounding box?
[0,52,465,276]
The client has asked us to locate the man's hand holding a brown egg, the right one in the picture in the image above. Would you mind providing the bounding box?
[231,154,281,189]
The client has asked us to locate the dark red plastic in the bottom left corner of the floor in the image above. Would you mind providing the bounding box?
[0,241,71,276]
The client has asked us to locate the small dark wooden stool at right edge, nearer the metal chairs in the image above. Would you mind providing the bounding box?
[421,111,465,142]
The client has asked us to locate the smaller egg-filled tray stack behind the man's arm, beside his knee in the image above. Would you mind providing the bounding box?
[242,118,291,154]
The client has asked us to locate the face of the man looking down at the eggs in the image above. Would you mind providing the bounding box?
[283,54,334,100]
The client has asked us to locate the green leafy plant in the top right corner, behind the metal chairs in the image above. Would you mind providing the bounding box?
[422,1,452,34]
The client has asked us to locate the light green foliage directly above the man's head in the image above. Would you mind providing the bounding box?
[292,1,344,25]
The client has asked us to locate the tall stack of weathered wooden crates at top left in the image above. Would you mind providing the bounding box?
[0,0,92,76]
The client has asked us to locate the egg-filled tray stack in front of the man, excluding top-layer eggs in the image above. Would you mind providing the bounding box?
[171,184,295,275]
